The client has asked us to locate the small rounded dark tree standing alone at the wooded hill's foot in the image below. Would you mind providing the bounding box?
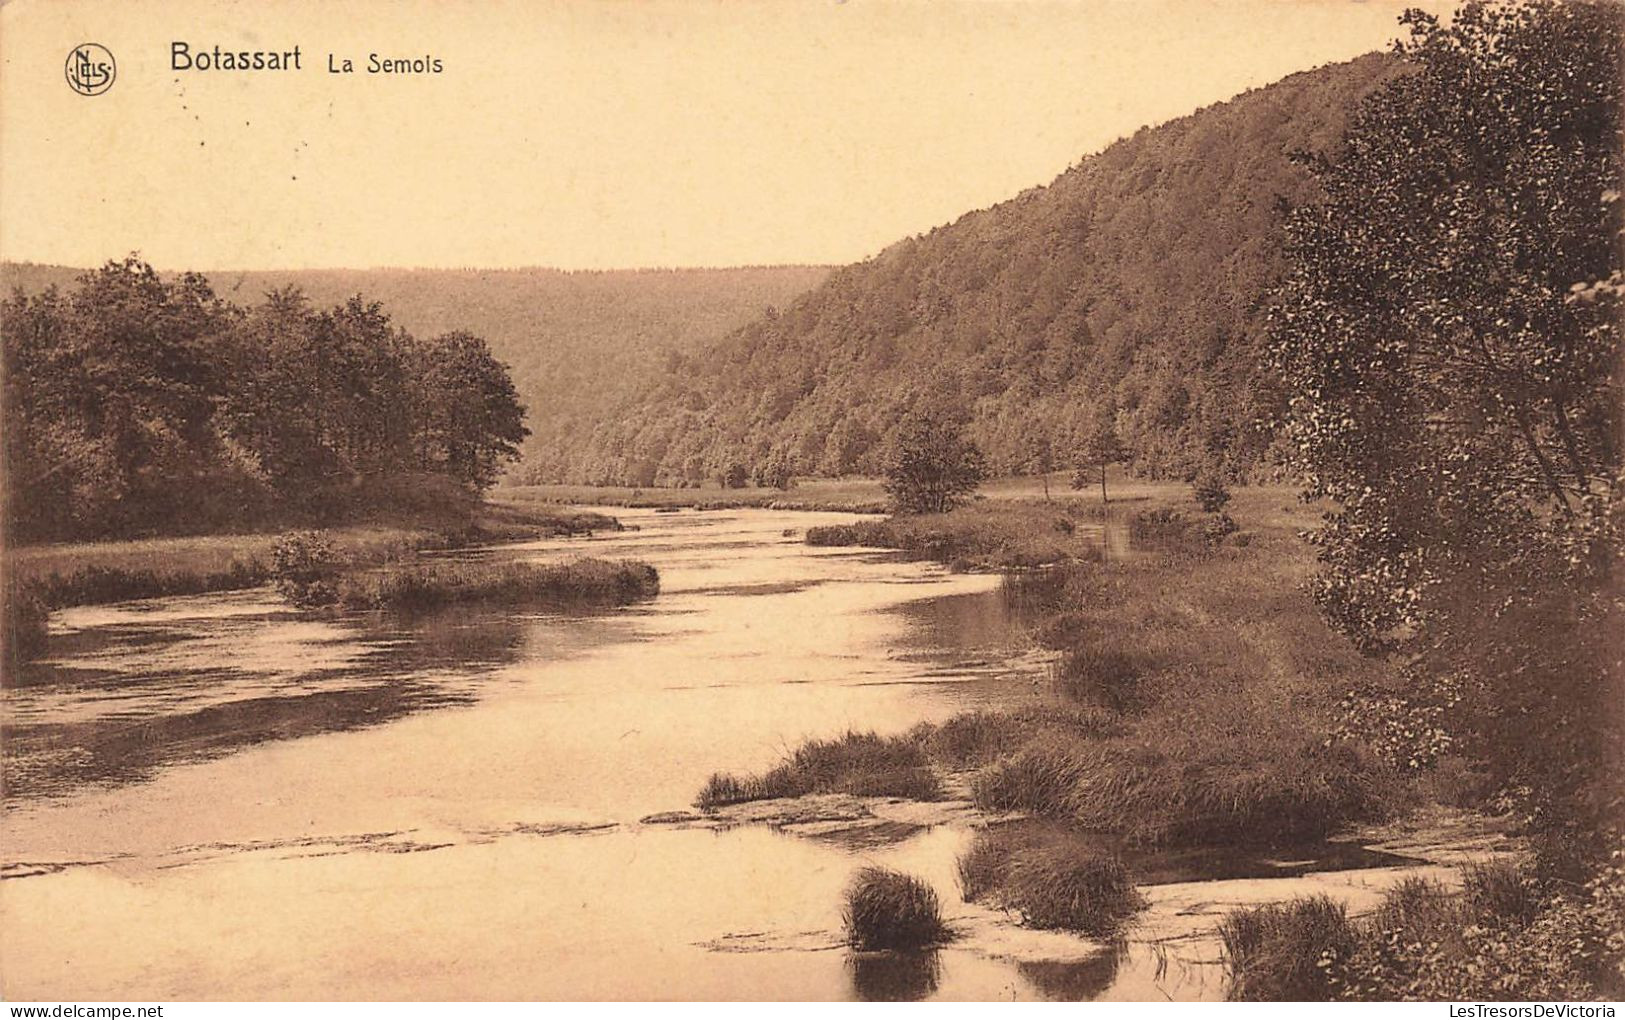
[886,406,985,513]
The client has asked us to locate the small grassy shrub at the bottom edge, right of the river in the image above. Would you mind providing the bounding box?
[1219,895,1355,1002]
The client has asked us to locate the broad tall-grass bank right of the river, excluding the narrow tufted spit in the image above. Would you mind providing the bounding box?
[780,486,1411,846]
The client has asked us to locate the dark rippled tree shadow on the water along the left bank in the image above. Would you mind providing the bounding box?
[0,607,570,802]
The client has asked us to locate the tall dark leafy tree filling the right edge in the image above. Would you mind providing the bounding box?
[1271,0,1625,832]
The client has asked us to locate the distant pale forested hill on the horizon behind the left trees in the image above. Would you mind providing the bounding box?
[0,261,829,477]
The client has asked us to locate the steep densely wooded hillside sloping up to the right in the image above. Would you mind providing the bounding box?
[549,54,1399,484]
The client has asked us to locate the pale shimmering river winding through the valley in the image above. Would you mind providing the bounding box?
[0,510,1449,1001]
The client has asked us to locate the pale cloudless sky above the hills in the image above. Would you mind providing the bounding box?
[0,0,1449,270]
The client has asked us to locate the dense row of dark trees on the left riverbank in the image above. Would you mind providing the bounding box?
[0,258,528,541]
